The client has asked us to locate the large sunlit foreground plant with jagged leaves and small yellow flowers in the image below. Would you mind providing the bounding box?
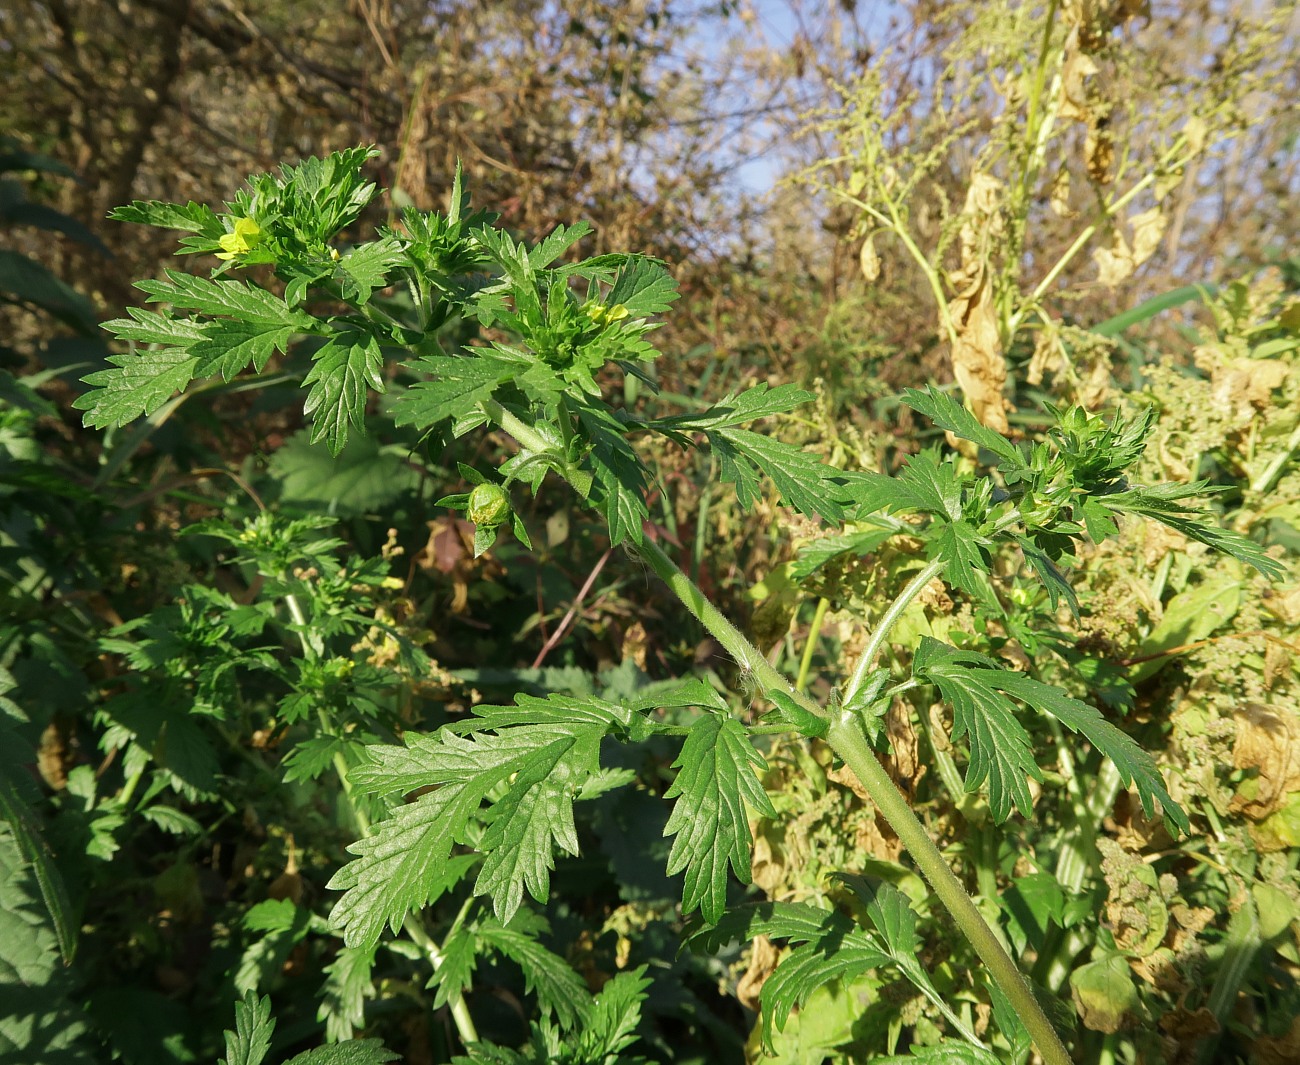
[78,150,1281,1065]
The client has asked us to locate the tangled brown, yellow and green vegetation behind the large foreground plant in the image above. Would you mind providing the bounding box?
[0,0,1300,1065]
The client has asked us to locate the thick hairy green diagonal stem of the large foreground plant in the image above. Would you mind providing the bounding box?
[482,399,1073,1065]
